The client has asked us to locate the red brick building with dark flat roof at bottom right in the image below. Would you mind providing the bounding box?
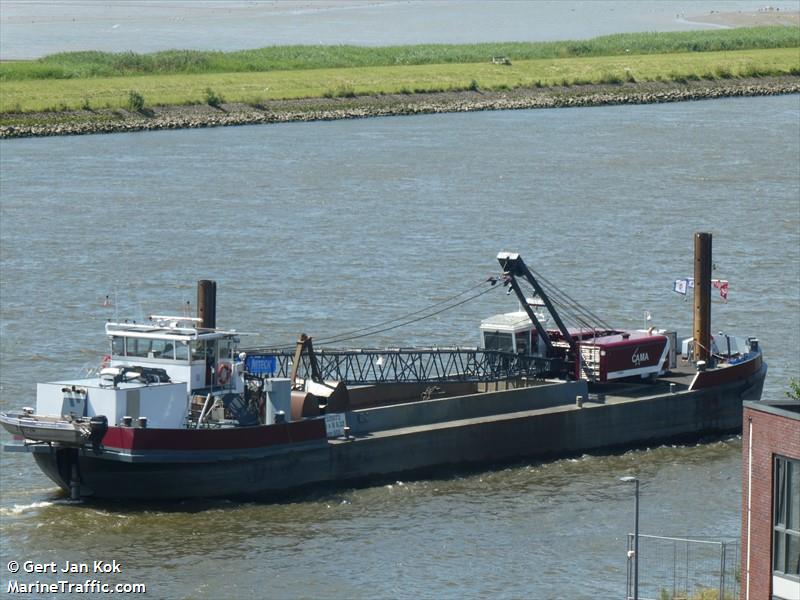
[740,401,800,600]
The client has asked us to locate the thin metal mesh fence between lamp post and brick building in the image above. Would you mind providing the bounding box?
[627,533,739,600]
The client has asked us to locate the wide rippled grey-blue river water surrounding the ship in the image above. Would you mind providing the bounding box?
[0,95,800,598]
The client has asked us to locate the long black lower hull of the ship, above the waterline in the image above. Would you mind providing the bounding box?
[26,364,767,500]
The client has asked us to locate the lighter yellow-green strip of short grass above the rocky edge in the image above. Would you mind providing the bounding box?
[0,47,800,113]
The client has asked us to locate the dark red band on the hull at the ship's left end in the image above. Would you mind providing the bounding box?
[103,419,326,450]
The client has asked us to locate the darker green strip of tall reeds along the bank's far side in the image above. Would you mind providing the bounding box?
[0,26,800,81]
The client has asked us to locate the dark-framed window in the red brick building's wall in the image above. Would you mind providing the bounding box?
[772,456,800,579]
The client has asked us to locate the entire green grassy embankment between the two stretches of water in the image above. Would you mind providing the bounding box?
[0,26,800,137]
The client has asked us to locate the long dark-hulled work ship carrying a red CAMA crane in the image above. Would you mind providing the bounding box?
[0,234,767,500]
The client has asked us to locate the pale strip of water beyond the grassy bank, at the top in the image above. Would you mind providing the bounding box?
[0,0,798,60]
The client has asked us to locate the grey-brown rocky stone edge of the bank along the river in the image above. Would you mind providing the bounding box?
[0,76,800,138]
